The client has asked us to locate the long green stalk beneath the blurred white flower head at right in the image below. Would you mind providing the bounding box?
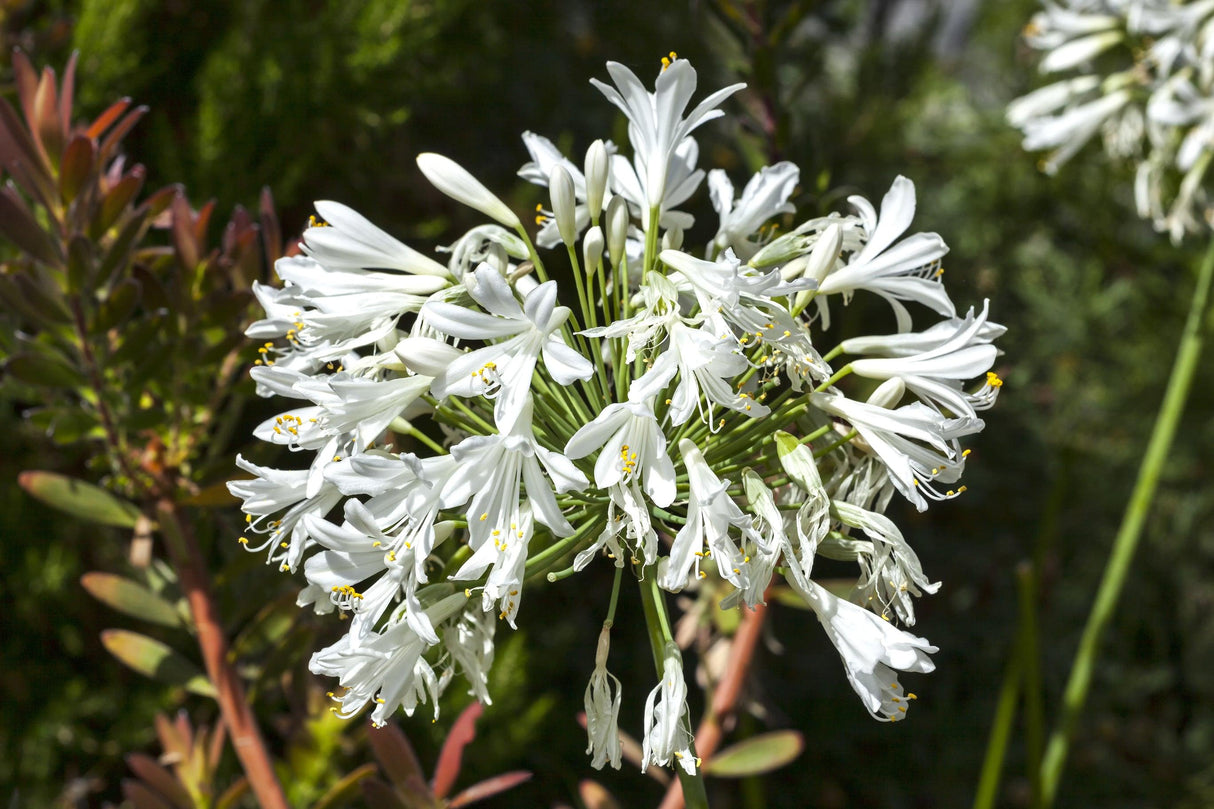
[1036,229,1214,809]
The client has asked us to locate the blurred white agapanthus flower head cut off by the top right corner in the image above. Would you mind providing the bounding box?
[1008,0,1214,242]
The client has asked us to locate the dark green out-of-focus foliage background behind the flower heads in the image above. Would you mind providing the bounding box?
[0,0,1214,809]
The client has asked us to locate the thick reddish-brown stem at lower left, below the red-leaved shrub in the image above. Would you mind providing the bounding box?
[157,497,289,809]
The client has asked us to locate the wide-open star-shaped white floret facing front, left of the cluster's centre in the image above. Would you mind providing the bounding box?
[424,267,594,431]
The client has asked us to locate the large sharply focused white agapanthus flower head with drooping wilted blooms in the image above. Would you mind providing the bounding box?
[231,56,1003,771]
